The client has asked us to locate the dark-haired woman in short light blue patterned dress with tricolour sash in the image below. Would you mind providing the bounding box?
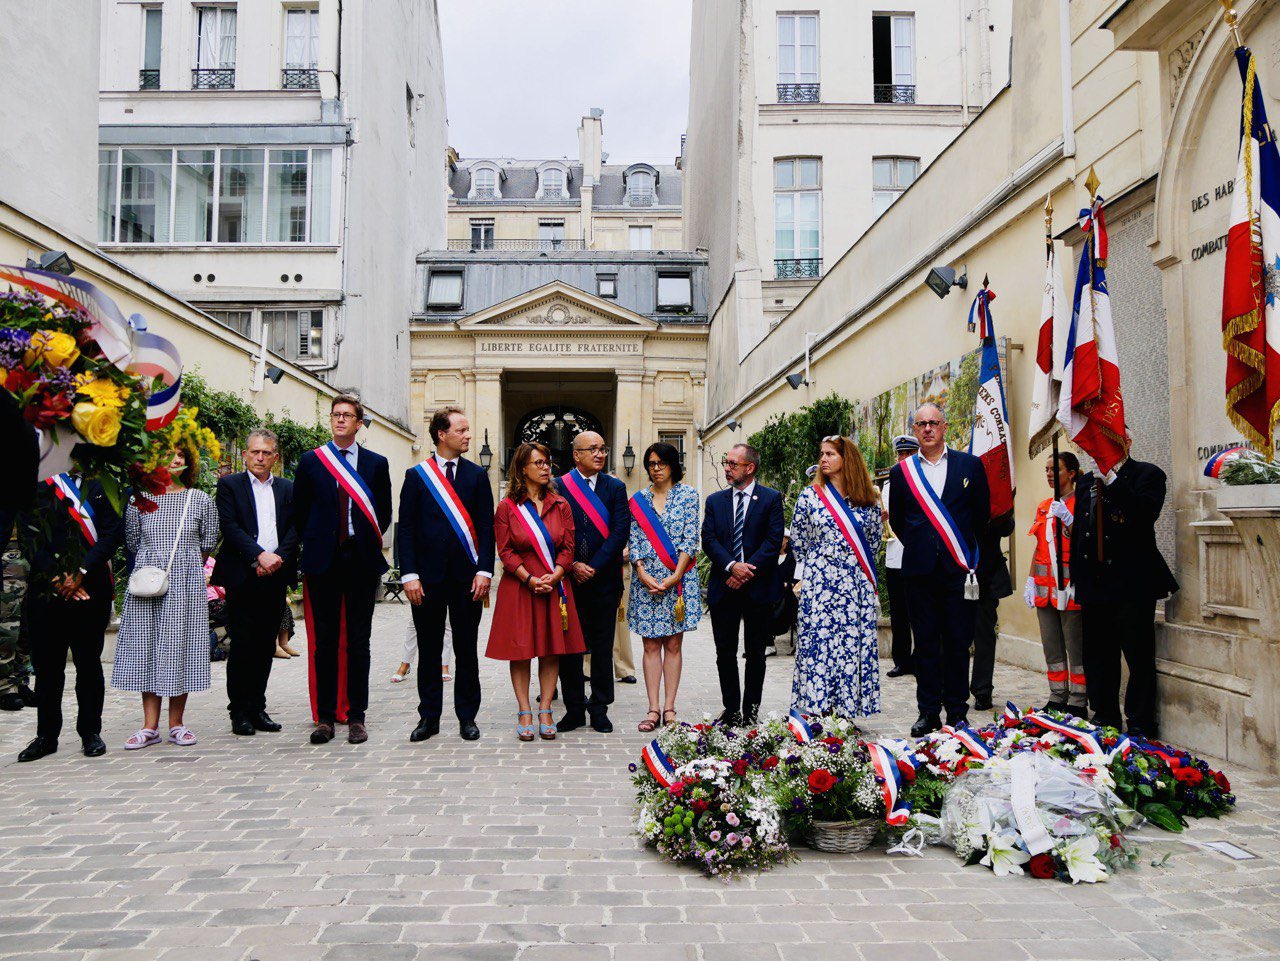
[627,443,703,732]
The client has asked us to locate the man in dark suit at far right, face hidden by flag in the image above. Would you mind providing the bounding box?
[1070,458,1178,737]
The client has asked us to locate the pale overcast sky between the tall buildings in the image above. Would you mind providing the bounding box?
[439,0,692,164]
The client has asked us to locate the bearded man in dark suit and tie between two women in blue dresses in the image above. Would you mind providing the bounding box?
[703,444,785,724]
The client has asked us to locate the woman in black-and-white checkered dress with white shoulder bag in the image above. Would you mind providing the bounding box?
[111,449,218,750]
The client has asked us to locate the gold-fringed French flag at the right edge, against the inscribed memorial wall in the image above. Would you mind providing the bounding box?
[1222,47,1280,461]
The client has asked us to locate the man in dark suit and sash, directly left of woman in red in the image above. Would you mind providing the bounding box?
[397,407,494,742]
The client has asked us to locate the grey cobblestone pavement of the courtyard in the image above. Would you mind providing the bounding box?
[0,603,1280,961]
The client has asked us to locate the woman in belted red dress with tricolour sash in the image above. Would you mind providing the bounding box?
[485,444,586,741]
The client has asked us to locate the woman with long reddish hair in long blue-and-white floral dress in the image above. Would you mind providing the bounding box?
[791,436,882,718]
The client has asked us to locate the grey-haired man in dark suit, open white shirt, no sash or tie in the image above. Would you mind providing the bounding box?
[212,427,298,735]
